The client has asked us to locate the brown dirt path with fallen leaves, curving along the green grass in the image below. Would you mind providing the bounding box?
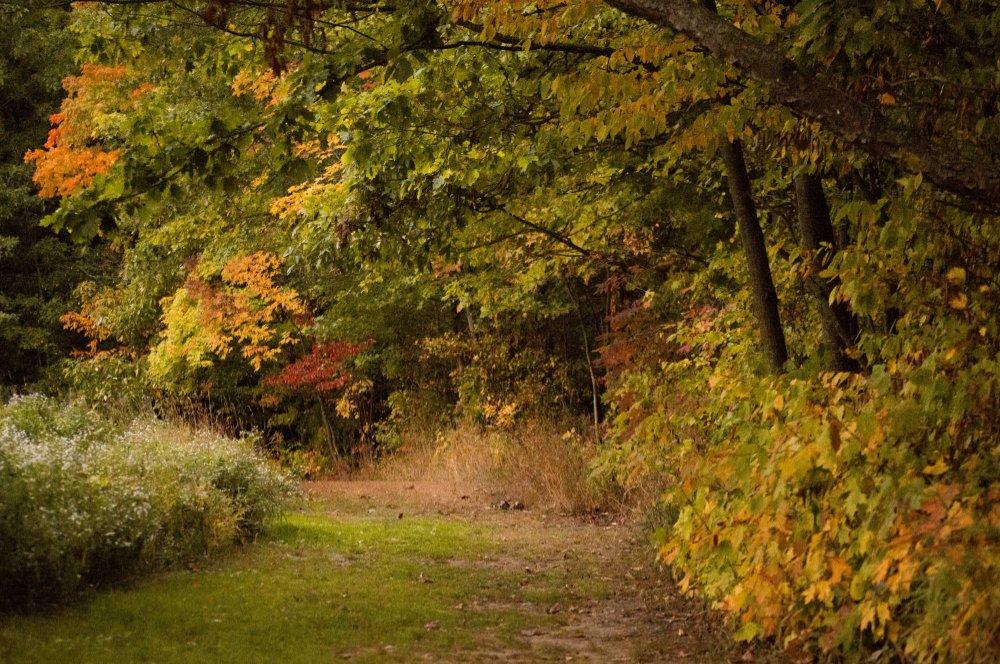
[306,480,760,662]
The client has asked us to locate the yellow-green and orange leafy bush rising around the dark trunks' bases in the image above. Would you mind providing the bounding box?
[602,233,1000,662]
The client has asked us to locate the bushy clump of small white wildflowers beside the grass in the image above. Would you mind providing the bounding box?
[0,396,292,606]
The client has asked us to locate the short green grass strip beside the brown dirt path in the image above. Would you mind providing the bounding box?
[0,505,603,664]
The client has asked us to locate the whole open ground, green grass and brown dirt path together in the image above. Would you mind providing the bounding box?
[0,481,756,663]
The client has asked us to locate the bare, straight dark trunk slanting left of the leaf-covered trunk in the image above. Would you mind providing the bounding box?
[720,141,788,371]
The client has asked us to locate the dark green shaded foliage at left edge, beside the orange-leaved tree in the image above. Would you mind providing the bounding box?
[0,3,102,384]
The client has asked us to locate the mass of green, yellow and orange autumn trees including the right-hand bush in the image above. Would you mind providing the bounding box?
[7,0,1000,661]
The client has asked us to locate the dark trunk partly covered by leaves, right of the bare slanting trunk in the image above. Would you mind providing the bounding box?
[795,174,860,371]
